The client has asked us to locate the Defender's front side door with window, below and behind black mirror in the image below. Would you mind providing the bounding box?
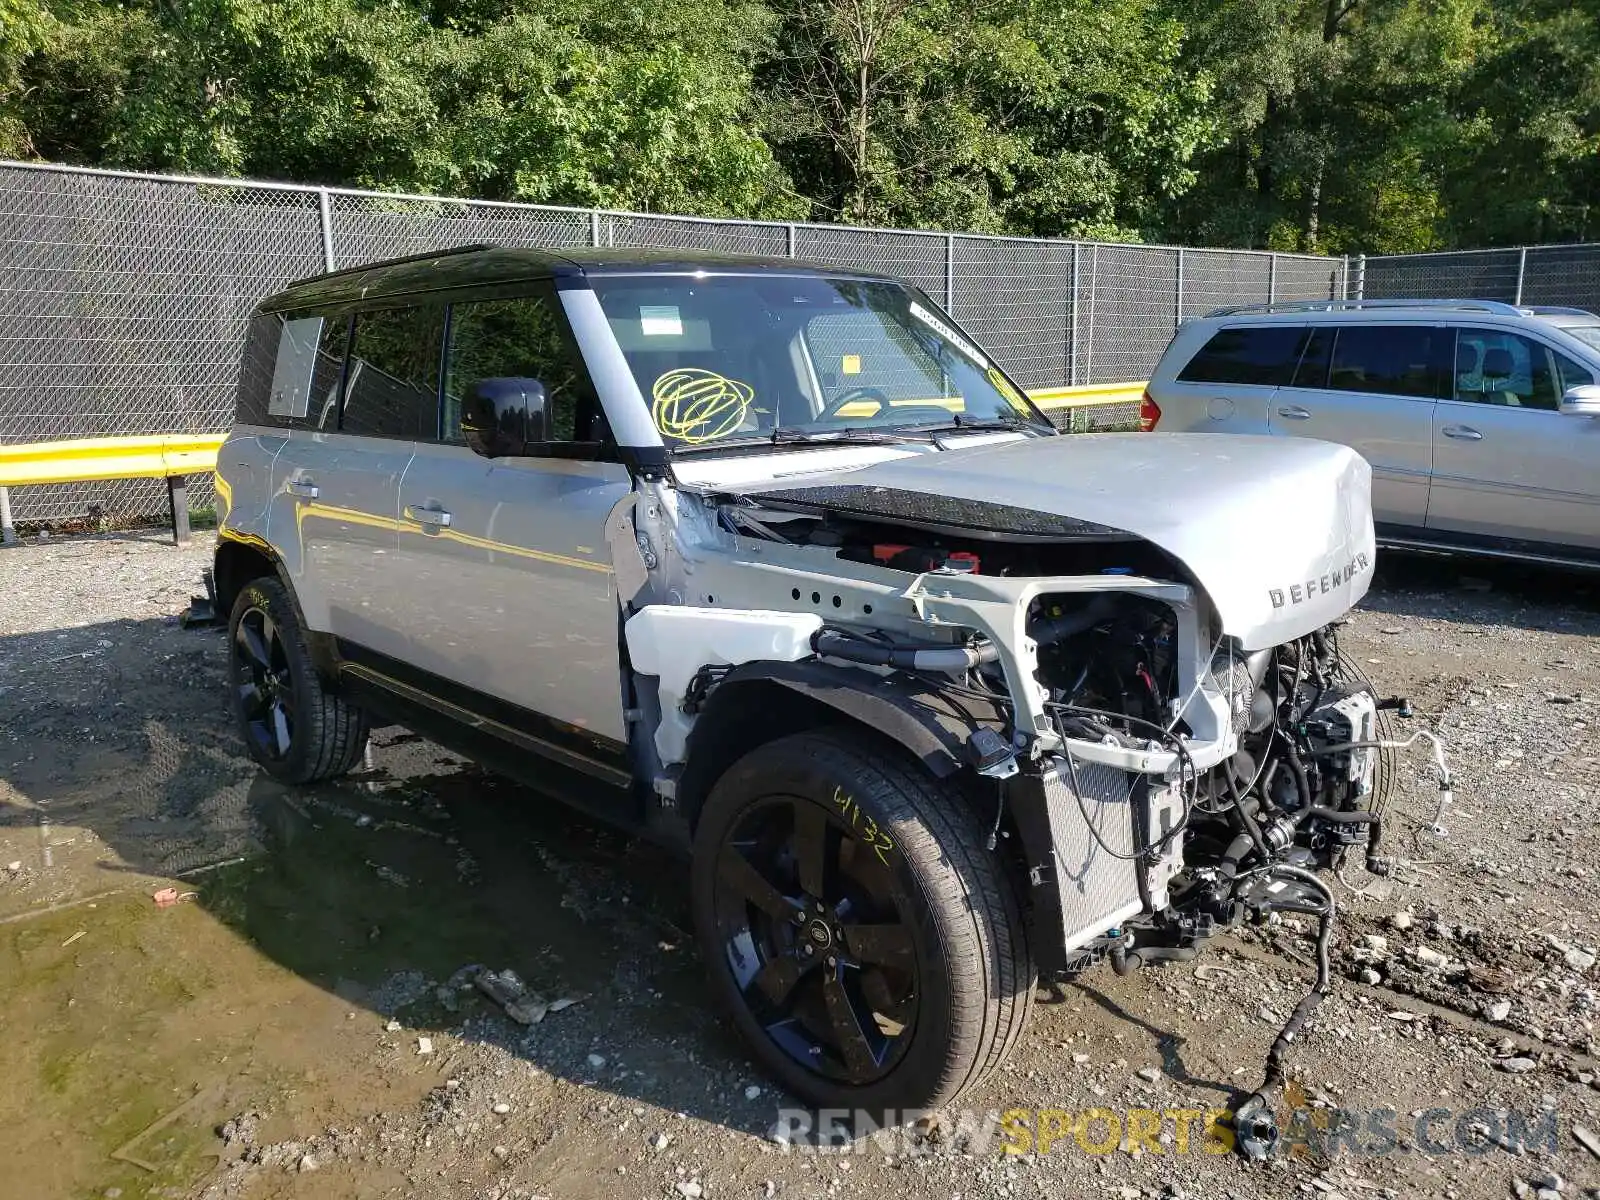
[400,288,632,752]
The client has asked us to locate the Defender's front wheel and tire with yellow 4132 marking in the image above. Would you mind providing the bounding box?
[693,728,1035,1114]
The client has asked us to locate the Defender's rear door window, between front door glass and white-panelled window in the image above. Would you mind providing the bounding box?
[339,306,445,442]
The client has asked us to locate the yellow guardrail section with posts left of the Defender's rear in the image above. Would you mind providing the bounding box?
[0,434,227,546]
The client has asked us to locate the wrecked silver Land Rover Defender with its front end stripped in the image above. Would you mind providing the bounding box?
[216,246,1427,1146]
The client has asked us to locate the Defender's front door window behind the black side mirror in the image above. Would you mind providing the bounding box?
[442,291,602,443]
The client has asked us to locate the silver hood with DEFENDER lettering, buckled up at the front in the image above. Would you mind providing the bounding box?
[741,434,1376,650]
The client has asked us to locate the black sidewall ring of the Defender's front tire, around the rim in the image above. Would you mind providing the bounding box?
[691,734,954,1123]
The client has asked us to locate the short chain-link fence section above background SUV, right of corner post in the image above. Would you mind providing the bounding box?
[1350,242,1600,312]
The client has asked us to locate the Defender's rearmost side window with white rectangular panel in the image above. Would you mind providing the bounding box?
[237,312,349,429]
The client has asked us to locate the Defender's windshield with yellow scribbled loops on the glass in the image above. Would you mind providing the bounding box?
[592,275,1054,450]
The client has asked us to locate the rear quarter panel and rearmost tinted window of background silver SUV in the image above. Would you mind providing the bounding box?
[1150,322,1306,434]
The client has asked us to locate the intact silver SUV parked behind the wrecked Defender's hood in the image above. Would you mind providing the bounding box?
[1147,301,1600,566]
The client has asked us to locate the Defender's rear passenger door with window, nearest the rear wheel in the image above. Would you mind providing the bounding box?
[269,307,443,656]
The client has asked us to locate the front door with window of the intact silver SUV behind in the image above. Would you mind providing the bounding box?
[1427,326,1600,550]
